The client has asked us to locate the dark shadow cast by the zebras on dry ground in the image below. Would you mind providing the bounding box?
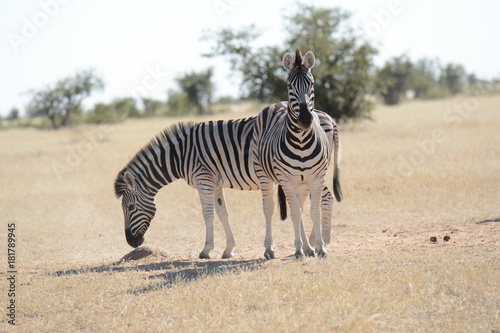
[50,248,267,295]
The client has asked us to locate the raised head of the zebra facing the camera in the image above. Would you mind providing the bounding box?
[283,49,315,131]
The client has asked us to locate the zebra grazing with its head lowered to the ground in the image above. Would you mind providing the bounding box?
[114,116,333,259]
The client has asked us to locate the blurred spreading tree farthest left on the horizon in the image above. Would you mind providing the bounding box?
[27,70,104,129]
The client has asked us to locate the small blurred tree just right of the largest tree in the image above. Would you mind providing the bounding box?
[376,55,414,105]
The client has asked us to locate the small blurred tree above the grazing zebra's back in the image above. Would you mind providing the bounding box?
[176,68,214,115]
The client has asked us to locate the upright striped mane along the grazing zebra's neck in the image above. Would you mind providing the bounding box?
[115,121,196,198]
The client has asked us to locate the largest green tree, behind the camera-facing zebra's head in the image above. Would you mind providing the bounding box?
[205,4,377,119]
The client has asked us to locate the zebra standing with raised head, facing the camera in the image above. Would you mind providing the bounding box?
[252,49,342,259]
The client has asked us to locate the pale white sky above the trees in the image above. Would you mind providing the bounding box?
[0,0,500,116]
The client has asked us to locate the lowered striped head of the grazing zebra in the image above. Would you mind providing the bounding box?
[115,169,156,247]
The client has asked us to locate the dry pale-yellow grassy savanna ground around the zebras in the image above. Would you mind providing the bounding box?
[0,96,500,332]
